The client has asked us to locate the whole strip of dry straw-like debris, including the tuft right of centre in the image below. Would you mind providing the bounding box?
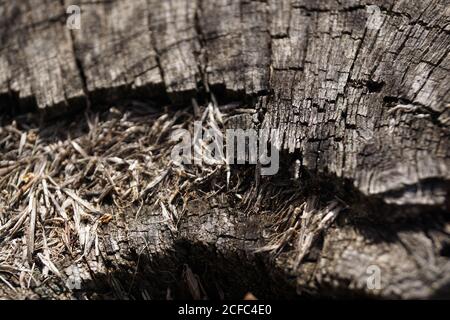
[0,101,343,296]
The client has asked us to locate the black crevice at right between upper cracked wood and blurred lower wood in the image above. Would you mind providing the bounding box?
[271,151,450,229]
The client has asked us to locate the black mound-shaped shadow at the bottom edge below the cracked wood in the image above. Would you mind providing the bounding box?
[72,240,298,300]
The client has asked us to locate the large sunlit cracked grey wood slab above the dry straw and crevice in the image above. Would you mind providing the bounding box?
[0,0,450,204]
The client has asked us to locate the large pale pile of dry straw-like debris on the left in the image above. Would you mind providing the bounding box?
[0,103,230,296]
